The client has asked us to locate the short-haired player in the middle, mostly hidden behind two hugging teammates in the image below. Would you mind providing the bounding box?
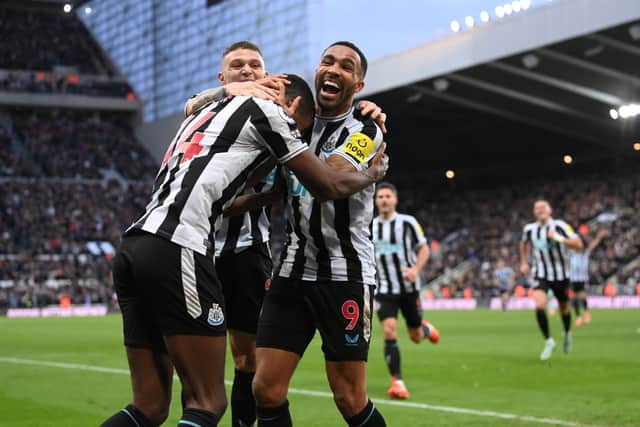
[185,41,385,427]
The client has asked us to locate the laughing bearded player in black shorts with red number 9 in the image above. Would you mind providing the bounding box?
[253,42,385,427]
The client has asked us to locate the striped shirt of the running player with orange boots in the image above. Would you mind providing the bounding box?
[372,213,427,295]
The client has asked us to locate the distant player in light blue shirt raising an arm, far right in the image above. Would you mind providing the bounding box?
[569,228,609,326]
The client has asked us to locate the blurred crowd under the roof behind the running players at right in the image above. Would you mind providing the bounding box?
[400,168,640,296]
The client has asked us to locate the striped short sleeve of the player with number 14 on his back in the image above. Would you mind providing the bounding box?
[251,98,309,163]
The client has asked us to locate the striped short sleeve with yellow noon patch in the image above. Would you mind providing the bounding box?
[329,118,382,170]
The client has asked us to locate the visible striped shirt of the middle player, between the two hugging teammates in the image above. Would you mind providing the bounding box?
[216,169,276,257]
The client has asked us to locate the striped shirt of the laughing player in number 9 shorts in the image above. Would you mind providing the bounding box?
[276,108,382,285]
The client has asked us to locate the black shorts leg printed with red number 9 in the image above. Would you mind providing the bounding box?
[305,281,374,362]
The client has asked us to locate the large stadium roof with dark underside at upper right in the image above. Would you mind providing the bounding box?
[361,0,640,179]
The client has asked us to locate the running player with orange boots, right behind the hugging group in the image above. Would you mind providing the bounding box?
[372,182,440,399]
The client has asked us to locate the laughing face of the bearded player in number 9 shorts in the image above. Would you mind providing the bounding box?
[315,45,364,117]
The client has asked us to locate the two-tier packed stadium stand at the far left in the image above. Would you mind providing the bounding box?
[0,6,152,309]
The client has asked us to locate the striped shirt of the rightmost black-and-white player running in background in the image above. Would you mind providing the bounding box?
[522,218,576,281]
